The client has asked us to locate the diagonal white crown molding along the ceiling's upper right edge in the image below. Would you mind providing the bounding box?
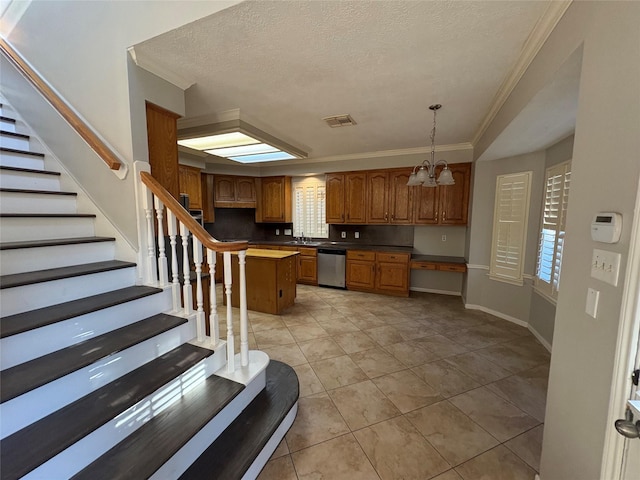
[471,0,573,145]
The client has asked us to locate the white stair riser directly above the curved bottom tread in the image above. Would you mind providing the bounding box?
[149,370,266,480]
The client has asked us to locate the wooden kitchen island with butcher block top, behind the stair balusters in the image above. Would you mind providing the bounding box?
[230,248,298,315]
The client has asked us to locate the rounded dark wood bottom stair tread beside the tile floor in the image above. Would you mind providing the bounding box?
[180,360,299,480]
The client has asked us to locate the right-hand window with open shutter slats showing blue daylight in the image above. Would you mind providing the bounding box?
[535,161,571,299]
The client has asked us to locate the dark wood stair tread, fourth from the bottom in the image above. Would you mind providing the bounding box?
[0,313,187,403]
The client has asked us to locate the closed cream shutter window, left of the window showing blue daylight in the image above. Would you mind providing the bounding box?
[489,172,532,285]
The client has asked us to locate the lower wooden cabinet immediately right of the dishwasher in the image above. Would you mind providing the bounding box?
[347,250,411,297]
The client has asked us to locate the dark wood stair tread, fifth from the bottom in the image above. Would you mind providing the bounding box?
[0,285,162,338]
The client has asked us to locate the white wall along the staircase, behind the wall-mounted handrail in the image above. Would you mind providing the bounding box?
[1,0,239,245]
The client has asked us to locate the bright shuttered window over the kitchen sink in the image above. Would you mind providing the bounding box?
[292,177,329,238]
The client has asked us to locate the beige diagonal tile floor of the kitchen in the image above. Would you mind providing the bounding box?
[225,286,549,480]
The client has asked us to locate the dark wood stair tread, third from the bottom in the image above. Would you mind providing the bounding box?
[0,343,213,479]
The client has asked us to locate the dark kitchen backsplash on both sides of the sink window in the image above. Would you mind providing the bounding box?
[205,208,414,247]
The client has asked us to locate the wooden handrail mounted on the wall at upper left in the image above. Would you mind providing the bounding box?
[0,38,122,170]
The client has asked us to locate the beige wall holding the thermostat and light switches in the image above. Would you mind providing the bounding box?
[476,2,640,480]
